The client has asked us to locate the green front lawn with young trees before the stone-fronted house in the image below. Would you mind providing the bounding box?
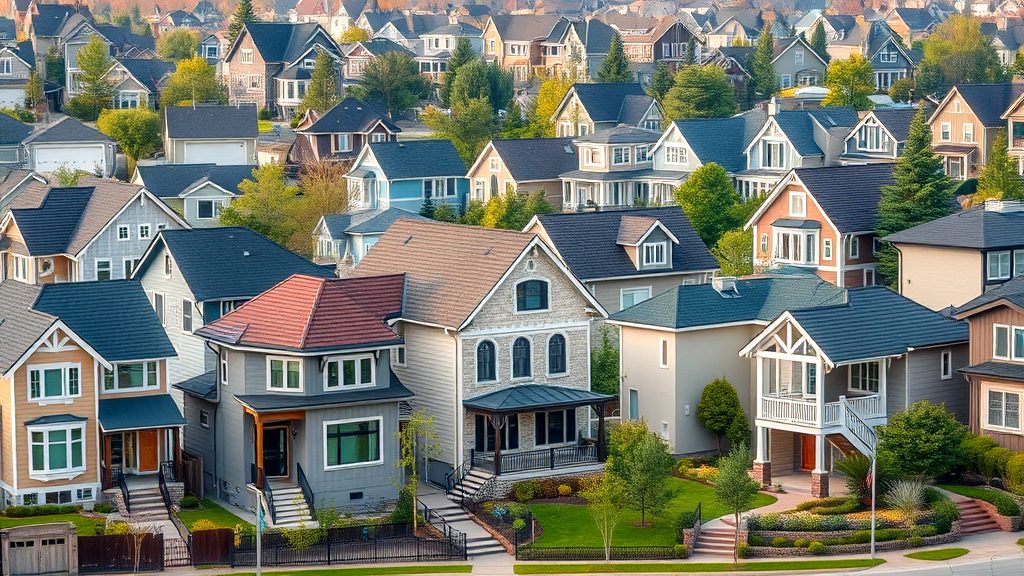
[529,477,775,546]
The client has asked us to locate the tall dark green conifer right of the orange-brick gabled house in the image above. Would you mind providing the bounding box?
[876,109,953,286]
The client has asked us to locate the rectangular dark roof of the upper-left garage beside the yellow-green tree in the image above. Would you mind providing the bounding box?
[164,106,259,138]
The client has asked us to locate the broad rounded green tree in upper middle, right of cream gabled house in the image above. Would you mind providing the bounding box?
[662,65,736,120]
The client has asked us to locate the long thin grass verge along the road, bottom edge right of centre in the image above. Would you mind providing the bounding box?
[515,558,886,574]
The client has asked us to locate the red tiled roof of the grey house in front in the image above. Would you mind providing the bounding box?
[196,275,406,352]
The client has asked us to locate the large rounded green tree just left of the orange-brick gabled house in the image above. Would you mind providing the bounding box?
[675,162,739,246]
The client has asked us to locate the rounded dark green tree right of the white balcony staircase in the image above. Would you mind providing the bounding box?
[879,400,967,478]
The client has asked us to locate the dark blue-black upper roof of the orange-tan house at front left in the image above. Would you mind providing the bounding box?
[33,280,177,362]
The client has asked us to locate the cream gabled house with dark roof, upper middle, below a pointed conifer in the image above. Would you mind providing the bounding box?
[552,83,665,137]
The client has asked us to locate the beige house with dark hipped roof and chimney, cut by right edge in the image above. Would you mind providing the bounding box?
[883,200,1024,310]
